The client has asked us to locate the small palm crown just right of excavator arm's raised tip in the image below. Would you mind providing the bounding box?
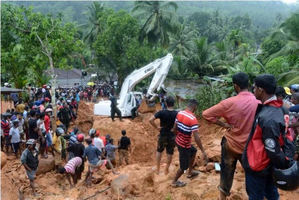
[168,24,198,58]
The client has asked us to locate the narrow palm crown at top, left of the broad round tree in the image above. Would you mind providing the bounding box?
[83,2,105,46]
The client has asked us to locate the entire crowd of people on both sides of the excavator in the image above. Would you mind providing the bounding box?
[1,76,299,200]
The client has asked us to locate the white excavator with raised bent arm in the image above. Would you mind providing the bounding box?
[94,53,173,117]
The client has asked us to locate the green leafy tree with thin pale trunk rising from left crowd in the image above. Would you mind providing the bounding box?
[3,4,82,119]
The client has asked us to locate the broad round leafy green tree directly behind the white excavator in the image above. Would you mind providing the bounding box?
[93,11,158,84]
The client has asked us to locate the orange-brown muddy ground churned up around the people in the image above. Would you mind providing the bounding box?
[1,103,299,200]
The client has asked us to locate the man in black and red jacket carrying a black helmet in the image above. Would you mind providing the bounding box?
[242,74,293,200]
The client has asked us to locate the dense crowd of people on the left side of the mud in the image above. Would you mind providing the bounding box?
[1,85,131,196]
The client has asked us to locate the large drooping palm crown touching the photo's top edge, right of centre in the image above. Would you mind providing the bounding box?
[132,1,178,46]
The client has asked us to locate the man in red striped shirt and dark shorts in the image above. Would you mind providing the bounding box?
[171,99,207,187]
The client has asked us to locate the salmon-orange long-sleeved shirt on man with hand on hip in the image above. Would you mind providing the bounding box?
[202,92,260,154]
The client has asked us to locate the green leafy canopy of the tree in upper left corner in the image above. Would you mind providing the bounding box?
[1,4,82,88]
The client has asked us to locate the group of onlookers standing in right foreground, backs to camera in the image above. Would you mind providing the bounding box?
[149,72,299,200]
